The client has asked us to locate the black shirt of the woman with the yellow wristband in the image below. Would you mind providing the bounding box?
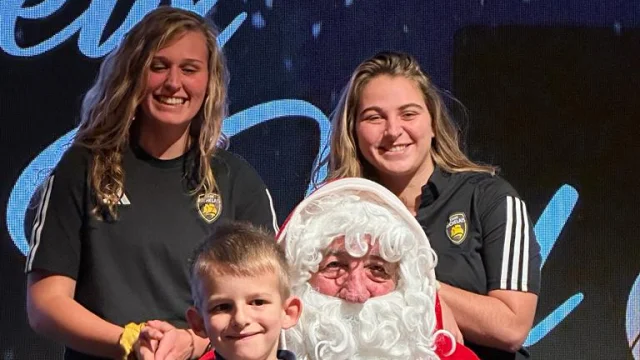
[26,146,277,359]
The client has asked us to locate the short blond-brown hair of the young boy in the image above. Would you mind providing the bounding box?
[190,222,291,308]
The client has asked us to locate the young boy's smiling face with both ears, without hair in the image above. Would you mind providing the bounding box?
[187,272,301,360]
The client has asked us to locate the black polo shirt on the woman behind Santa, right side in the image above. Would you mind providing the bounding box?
[416,167,541,359]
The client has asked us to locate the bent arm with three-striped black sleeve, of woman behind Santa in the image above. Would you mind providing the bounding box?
[440,178,540,352]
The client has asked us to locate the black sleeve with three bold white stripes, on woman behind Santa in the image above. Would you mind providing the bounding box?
[477,177,541,294]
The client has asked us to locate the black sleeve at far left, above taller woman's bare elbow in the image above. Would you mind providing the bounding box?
[25,147,88,279]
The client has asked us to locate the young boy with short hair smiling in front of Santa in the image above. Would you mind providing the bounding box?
[187,222,302,360]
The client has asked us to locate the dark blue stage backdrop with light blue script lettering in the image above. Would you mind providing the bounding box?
[0,0,640,360]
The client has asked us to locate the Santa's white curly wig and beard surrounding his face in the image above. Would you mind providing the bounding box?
[279,190,450,360]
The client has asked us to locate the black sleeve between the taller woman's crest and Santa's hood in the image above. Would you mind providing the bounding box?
[228,154,278,234]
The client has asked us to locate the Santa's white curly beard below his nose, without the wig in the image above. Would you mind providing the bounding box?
[285,284,438,360]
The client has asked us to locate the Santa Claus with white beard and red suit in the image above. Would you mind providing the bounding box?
[277,178,477,360]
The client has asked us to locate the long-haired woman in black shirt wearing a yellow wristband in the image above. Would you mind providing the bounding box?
[26,6,277,359]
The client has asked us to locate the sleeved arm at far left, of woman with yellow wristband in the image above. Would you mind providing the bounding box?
[25,147,134,357]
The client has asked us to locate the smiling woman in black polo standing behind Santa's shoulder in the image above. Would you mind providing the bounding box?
[316,52,540,359]
